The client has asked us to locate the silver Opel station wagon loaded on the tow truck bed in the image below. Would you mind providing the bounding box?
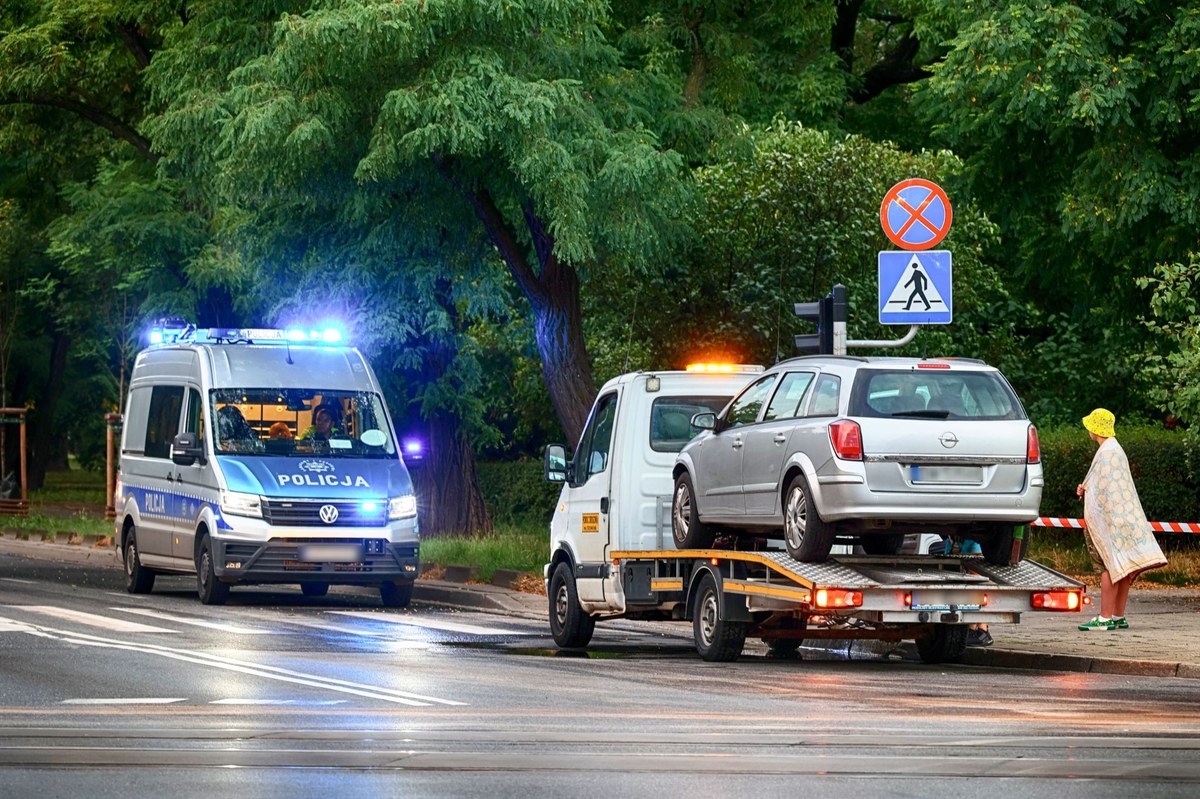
[671,355,1043,564]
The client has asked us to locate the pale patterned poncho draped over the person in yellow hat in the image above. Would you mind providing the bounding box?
[1084,438,1166,582]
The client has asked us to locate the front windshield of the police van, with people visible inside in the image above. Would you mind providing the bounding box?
[209,388,396,458]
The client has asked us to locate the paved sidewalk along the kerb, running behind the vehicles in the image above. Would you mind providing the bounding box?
[0,527,1200,679]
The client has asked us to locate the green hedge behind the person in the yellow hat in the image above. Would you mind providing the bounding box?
[1038,422,1200,522]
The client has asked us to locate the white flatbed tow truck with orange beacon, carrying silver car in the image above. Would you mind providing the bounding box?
[545,364,1086,663]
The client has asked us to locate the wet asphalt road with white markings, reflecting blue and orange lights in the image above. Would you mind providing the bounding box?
[0,557,1200,799]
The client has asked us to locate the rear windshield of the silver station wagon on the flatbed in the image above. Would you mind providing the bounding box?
[850,368,1025,419]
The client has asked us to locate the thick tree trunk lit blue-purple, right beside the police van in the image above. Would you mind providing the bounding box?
[413,414,493,539]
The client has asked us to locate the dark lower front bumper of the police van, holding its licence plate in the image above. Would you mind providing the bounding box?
[212,537,420,585]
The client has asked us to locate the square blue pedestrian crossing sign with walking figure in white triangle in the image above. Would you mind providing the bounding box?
[880,250,954,325]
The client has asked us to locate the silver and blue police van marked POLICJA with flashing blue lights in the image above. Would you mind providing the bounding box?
[114,323,419,607]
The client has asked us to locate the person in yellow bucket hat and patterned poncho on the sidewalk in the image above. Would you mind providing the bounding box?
[1075,408,1166,631]
